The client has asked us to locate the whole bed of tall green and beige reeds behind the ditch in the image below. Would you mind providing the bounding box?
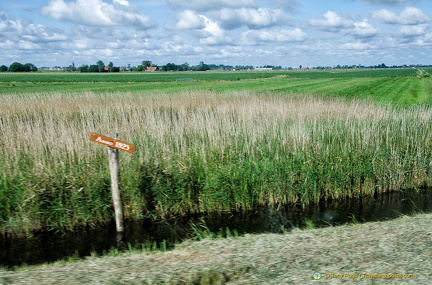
[0,91,432,232]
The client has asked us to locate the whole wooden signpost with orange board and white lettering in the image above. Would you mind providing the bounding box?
[90,133,135,233]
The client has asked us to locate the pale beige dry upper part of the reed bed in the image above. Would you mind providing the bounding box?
[0,89,431,171]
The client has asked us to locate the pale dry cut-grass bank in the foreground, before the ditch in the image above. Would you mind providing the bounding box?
[0,214,432,285]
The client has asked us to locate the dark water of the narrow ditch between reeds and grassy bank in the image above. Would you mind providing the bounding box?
[0,189,432,267]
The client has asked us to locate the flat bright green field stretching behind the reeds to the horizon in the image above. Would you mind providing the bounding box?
[0,69,432,105]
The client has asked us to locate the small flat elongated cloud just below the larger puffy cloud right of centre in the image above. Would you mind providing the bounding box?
[242,28,306,44]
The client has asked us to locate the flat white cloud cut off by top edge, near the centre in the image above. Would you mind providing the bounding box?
[168,0,258,11]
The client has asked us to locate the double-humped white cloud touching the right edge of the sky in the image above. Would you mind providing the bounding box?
[372,7,430,25]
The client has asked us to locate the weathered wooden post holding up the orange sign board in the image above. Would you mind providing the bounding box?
[107,133,124,233]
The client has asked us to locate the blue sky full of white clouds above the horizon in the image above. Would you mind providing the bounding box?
[0,0,432,67]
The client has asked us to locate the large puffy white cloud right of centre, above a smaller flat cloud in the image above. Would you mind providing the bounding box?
[212,8,292,29]
